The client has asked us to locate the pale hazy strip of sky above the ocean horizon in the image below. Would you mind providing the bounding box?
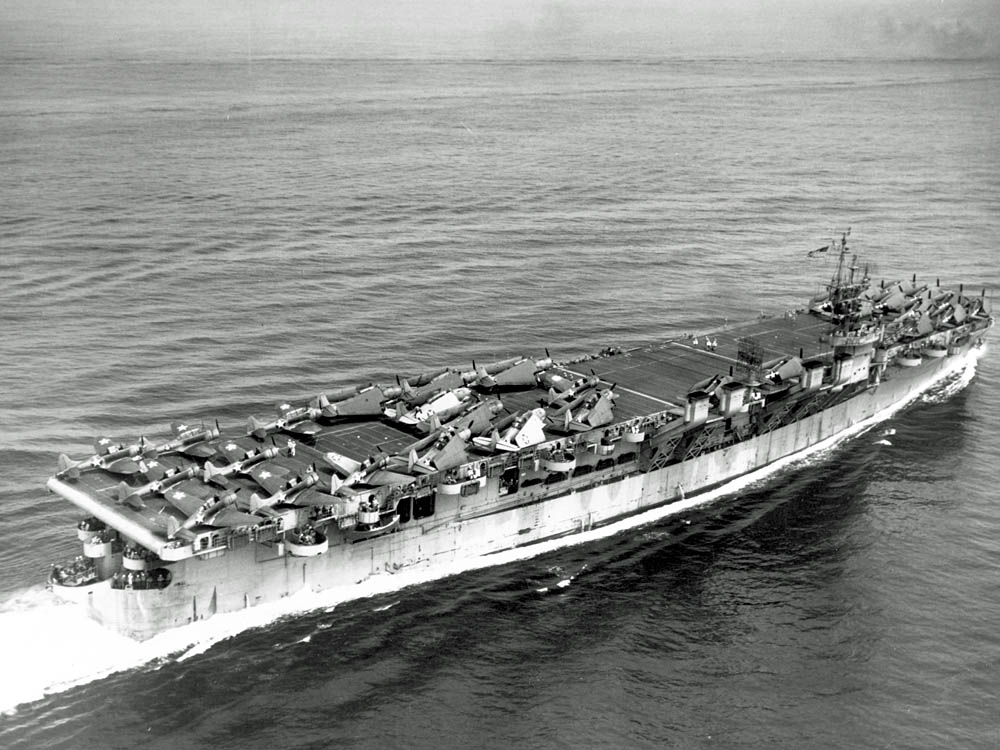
[0,0,1000,58]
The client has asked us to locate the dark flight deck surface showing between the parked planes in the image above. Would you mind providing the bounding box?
[52,313,832,534]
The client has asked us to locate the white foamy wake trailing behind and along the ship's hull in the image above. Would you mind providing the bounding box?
[0,350,976,713]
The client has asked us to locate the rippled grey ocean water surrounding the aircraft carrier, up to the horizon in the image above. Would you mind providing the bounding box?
[0,50,1000,749]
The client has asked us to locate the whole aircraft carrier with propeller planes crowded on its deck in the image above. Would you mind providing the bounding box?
[48,236,993,640]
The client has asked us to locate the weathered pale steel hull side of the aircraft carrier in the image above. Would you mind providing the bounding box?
[55,345,980,640]
